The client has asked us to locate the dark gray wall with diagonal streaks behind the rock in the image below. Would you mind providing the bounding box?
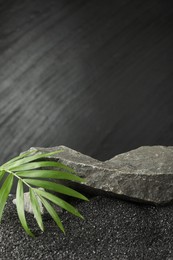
[0,0,173,166]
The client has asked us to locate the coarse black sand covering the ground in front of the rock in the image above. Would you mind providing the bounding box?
[0,197,173,260]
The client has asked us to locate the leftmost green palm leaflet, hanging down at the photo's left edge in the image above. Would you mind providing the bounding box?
[0,174,13,222]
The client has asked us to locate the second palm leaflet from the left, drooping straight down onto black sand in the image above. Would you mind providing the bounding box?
[16,180,34,237]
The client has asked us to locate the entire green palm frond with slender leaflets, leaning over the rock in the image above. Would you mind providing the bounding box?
[0,150,88,237]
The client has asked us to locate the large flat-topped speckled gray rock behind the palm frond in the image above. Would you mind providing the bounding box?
[15,146,173,204]
